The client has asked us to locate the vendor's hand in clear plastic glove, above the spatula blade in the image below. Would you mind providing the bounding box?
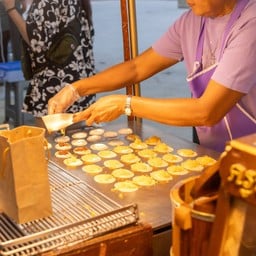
[48,84,80,115]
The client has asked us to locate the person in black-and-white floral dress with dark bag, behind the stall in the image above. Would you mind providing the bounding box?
[2,0,95,123]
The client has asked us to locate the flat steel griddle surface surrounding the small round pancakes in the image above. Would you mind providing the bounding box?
[48,121,219,230]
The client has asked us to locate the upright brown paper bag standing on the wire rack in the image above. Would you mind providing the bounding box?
[0,126,52,223]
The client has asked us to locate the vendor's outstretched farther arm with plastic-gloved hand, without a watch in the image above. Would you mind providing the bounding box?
[48,48,178,114]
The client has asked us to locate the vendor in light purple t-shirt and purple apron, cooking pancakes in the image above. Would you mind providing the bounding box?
[48,0,256,152]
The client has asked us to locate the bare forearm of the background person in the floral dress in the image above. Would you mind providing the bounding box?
[2,0,30,45]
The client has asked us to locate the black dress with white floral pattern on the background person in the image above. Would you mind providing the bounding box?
[23,0,95,117]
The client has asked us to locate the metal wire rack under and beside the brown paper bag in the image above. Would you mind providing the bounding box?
[0,162,139,256]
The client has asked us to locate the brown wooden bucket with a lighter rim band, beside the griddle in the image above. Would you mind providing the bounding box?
[170,177,217,256]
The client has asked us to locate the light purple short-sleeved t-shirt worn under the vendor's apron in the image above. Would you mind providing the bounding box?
[152,0,256,117]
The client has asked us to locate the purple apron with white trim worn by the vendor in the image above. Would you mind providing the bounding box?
[187,0,256,152]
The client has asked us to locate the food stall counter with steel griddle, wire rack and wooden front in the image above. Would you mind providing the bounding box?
[0,120,218,256]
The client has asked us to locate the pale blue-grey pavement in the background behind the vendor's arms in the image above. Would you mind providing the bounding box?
[0,0,192,140]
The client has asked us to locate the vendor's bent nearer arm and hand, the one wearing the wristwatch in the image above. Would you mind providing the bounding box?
[75,80,243,126]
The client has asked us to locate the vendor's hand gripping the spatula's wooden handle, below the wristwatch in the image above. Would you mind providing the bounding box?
[73,95,126,126]
